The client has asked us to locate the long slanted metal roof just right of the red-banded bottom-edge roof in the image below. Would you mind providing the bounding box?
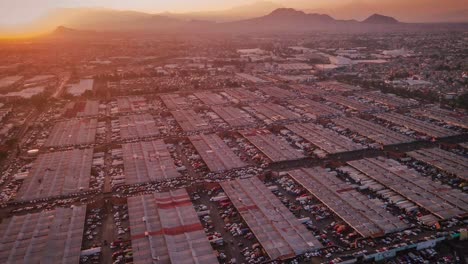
[221,177,322,259]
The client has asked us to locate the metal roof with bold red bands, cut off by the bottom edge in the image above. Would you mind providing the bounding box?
[127,189,218,264]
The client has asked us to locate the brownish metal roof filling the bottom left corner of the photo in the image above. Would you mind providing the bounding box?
[0,206,86,264]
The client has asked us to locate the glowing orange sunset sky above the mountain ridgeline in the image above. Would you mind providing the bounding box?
[0,0,468,37]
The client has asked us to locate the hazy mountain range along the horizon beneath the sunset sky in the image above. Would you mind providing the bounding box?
[4,5,466,36]
